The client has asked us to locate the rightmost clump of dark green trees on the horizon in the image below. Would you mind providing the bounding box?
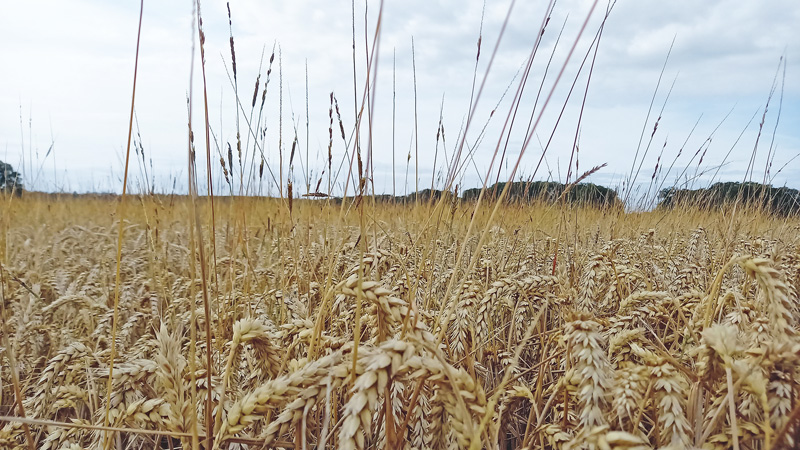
[658,182,800,216]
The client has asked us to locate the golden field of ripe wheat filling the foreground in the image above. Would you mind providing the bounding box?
[0,195,800,450]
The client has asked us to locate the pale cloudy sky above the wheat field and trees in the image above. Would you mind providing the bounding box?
[0,0,800,200]
